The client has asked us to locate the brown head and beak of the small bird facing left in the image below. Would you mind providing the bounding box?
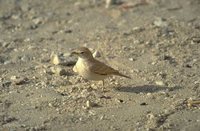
[71,47,93,59]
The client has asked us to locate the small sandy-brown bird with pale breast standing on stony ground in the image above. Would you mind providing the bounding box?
[71,47,131,85]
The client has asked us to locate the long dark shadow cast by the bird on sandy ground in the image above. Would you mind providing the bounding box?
[115,85,181,93]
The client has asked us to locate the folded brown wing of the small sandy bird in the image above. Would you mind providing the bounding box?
[89,60,119,75]
